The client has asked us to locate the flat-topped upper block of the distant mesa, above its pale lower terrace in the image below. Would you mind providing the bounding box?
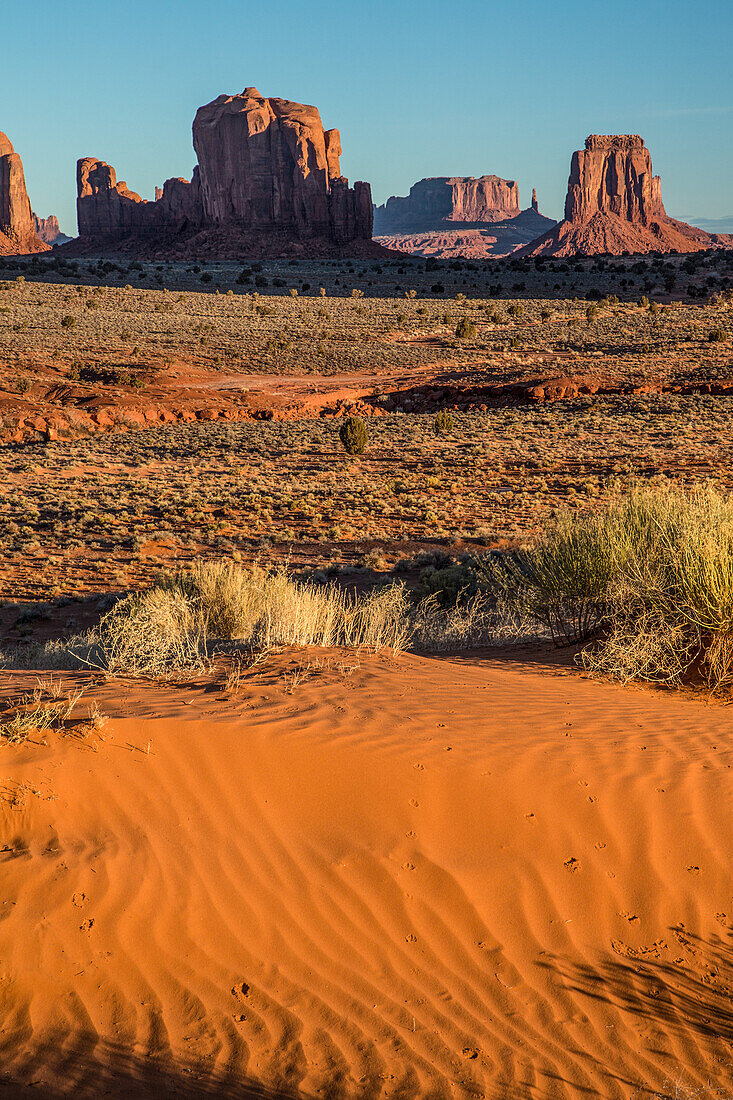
[374,176,519,235]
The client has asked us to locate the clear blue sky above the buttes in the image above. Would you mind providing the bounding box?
[5,0,733,232]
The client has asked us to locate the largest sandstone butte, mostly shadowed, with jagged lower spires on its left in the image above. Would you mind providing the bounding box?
[77,88,376,256]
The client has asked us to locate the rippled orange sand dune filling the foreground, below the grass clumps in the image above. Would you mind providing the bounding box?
[0,650,733,1098]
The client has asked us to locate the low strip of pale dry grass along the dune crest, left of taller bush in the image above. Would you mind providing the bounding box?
[18,562,527,677]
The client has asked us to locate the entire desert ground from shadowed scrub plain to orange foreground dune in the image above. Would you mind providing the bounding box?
[0,243,733,1100]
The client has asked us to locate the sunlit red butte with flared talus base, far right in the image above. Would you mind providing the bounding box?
[517,134,733,256]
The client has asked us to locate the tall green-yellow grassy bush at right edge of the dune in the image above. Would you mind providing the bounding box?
[515,488,733,690]
